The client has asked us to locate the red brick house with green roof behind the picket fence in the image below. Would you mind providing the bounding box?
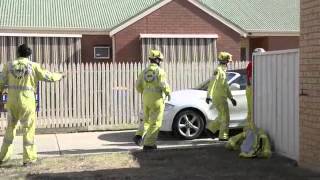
[0,0,299,63]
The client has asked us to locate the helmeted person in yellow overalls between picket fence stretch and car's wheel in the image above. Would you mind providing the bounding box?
[134,50,171,150]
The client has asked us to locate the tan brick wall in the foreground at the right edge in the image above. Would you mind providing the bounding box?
[299,0,320,171]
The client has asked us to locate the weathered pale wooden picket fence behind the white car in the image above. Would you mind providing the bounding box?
[0,62,247,130]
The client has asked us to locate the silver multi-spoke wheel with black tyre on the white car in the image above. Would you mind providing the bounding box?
[173,110,204,140]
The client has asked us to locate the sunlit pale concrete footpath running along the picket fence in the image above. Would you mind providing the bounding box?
[0,130,219,159]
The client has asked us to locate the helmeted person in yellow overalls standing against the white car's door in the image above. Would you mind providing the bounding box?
[206,52,237,141]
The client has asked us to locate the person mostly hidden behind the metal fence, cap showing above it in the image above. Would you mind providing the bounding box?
[244,48,265,131]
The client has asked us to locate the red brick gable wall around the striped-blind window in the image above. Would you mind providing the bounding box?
[115,0,240,61]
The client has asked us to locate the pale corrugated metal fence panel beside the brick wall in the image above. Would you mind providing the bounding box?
[254,50,299,160]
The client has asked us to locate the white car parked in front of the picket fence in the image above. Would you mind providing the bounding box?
[161,70,247,139]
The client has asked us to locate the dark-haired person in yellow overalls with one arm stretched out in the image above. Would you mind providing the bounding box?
[0,44,64,166]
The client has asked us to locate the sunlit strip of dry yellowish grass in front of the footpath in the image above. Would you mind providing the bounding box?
[0,153,139,179]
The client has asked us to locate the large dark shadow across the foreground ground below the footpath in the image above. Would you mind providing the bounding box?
[27,145,320,180]
